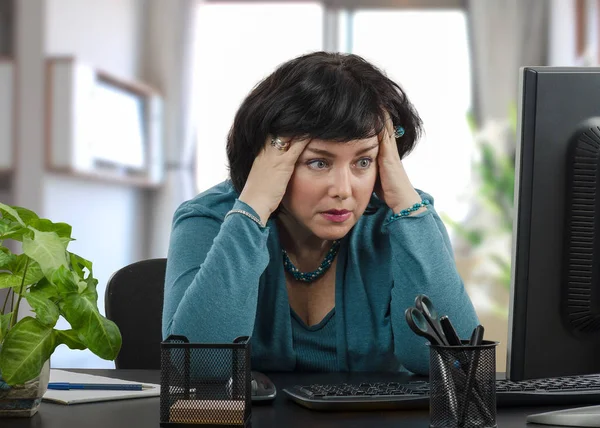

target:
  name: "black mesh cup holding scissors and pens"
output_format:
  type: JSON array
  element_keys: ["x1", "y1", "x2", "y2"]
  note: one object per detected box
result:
[{"x1": 429, "y1": 340, "x2": 498, "y2": 428}]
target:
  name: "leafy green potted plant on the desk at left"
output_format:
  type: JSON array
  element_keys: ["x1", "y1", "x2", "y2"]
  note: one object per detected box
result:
[{"x1": 0, "y1": 203, "x2": 121, "y2": 416}]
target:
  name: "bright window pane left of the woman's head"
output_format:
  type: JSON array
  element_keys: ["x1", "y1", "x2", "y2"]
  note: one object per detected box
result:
[{"x1": 196, "y1": 3, "x2": 323, "y2": 192}]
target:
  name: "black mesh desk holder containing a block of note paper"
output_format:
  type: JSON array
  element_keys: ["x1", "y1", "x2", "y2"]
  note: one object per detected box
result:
[{"x1": 160, "y1": 336, "x2": 252, "y2": 428}]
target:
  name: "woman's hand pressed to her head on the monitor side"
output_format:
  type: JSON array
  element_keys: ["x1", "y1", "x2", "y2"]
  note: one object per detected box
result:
[{"x1": 375, "y1": 111, "x2": 424, "y2": 214}]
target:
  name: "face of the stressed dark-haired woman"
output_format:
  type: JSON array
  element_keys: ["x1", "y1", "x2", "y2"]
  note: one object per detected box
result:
[{"x1": 282, "y1": 136, "x2": 379, "y2": 240}]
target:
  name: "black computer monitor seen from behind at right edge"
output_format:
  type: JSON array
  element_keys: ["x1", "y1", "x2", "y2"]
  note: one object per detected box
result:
[{"x1": 507, "y1": 67, "x2": 600, "y2": 380}]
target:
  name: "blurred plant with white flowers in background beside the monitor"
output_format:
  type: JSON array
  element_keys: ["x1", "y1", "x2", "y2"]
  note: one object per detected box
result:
[{"x1": 442, "y1": 106, "x2": 517, "y2": 320}]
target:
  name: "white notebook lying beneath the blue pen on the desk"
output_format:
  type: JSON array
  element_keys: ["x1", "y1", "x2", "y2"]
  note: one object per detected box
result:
[{"x1": 43, "y1": 369, "x2": 160, "y2": 404}]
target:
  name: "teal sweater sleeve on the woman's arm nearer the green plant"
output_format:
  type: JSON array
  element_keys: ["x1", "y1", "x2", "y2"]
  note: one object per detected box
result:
[{"x1": 162, "y1": 200, "x2": 269, "y2": 343}]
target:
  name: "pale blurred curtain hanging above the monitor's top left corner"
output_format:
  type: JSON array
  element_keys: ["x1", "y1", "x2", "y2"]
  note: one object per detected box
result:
[{"x1": 467, "y1": 0, "x2": 550, "y2": 127}]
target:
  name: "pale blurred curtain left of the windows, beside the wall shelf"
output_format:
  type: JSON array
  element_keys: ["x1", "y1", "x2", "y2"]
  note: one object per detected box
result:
[{"x1": 143, "y1": 0, "x2": 197, "y2": 258}]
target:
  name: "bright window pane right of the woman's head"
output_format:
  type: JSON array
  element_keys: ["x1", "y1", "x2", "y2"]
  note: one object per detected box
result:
[{"x1": 349, "y1": 10, "x2": 473, "y2": 220}]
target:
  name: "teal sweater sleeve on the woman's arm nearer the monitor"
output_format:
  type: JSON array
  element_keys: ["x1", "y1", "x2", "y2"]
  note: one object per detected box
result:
[{"x1": 384, "y1": 193, "x2": 478, "y2": 375}]
